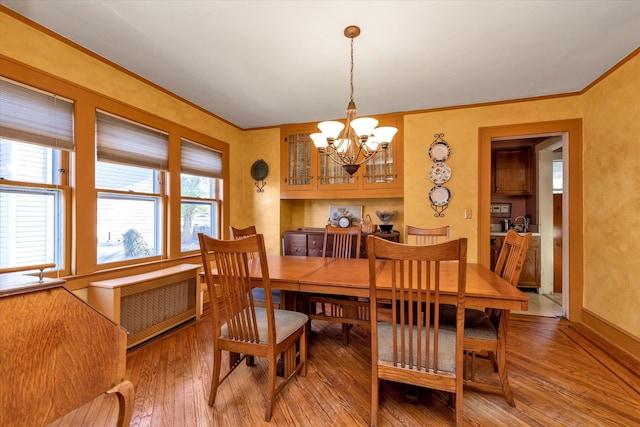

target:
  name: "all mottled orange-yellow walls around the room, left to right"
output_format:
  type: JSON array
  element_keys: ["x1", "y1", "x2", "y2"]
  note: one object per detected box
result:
[{"x1": 0, "y1": 8, "x2": 640, "y2": 354}]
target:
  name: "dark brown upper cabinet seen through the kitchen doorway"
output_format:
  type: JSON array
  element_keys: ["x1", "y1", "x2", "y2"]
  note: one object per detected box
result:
[{"x1": 492, "y1": 147, "x2": 532, "y2": 196}]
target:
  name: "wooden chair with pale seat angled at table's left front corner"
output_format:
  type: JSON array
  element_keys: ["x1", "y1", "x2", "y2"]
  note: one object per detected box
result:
[{"x1": 198, "y1": 233, "x2": 309, "y2": 421}]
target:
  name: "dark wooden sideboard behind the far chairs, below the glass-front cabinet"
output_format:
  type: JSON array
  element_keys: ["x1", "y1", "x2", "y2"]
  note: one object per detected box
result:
[{"x1": 282, "y1": 227, "x2": 400, "y2": 258}]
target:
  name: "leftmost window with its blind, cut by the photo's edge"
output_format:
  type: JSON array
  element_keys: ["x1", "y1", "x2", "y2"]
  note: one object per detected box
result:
[{"x1": 0, "y1": 78, "x2": 74, "y2": 270}]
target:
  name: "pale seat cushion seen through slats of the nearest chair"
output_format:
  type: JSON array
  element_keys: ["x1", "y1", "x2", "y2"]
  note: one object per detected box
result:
[{"x1": 378, "y1": 322, "x2": 456, "y2": 373}]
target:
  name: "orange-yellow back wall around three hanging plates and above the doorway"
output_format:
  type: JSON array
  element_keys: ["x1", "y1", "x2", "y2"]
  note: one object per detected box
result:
[{"x1": 404, "y1": 97, "x2": 582, "y2": 262}]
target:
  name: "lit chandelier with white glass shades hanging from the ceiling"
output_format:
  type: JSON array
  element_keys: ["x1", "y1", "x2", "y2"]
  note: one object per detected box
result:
[{"x1": 310, "y1": 25, "x2": 398, "y2": 175}]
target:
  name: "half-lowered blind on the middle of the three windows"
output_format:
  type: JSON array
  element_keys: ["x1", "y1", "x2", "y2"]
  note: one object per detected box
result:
[{"x1": 96, "y1": 111, "x2": 169, "y2": 170}]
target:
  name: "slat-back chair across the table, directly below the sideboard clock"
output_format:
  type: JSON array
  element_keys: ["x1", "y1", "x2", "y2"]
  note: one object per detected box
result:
[{"x1": 307, "y1": 225, "x2": 369, "y2": 345}]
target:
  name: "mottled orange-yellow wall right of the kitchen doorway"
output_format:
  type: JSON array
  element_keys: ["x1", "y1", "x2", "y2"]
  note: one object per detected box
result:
[{"x1": 583, "y1": 51, "x2": 640, "y2": 337}]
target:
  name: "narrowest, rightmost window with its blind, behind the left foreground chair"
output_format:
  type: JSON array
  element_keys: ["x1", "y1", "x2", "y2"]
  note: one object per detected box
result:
[{"x1": 180, "y1": 139, "x2": 222, "y2": 252}]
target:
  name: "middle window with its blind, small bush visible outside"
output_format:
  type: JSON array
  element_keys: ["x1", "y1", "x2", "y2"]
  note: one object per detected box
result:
[{"x1": 96, "y1": 112, "x2": 169, "y2": 264}]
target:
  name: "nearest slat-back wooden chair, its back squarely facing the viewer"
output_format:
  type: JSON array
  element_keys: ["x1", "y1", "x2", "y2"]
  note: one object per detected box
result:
[{"x1": 367, "y1": 237, "x2": 467, "y2": 426}]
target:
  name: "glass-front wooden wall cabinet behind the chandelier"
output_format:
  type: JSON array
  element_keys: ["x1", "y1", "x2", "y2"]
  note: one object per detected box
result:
[{"x1": 280, "y1": 115, "x2": 404, "y2": 199}]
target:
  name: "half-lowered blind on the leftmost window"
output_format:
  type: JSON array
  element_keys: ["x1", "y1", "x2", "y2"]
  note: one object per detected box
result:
[{"x1": 0, "y1": 78, "x2": 74, "y2": 151}]
